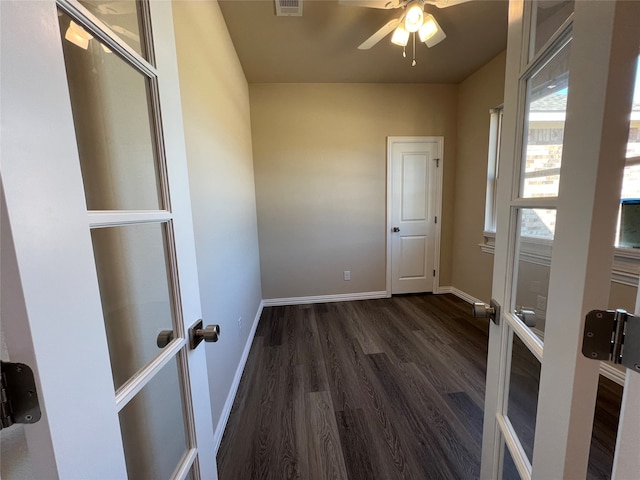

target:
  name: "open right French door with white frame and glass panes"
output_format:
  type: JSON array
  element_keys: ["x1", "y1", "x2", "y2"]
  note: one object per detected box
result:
[{"x1": 481, "y1": 0, "x2": 640, "y2": 479}]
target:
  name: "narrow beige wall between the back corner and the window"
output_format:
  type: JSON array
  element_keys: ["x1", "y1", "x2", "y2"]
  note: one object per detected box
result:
[{"x1": 451, "y1": 52, "x2": 505, "y2": 301}]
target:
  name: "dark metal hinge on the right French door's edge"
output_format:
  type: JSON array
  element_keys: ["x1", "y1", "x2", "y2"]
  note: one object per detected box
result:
[{"x1": 582, "y1": 309, "x2": 640, "y2": 372}]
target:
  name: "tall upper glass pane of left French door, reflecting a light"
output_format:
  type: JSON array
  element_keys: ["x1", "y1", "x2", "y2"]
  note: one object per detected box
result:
[{"x1": 59, "y1": 12, "x2": 162, "y2": 210}]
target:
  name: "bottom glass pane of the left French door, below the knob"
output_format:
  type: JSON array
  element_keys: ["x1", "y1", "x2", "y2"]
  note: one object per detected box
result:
[{"x1": 120, "y1": 357, "x2": 188, "y2": 480}]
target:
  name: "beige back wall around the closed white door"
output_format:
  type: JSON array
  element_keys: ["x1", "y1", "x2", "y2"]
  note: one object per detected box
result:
[{"x1": 249, "y1": 84, "x2": 457, "y2": 299}]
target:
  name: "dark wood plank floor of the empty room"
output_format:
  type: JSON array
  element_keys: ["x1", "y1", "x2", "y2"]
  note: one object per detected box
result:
[{"x1": 218, "y1": 295, "x2": 621, "y2": 480}]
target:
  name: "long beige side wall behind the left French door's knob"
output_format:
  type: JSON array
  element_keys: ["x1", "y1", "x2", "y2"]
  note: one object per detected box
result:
[{"x1": 173, "y1": 1, "x2": 262, "y2": 442}]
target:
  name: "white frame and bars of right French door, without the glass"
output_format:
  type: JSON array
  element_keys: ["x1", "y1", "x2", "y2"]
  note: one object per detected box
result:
[{"x1": 481, "y1": 0, "x2": 640, "y2": 479}]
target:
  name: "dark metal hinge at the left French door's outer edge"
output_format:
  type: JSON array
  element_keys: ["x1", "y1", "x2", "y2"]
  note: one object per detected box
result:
[{"x1": 0, "y1": 362, "x2": 41, "y2": 429}]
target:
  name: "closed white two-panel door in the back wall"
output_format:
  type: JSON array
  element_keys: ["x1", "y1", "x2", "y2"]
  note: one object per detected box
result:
[{"x1": 387, "y1": 137, "x2": 443, "y2": 294}]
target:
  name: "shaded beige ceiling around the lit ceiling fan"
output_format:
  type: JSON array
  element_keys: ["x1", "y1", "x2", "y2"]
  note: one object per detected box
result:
[{"x1": 219, "y1": 0, "x2": 508, "y2": 83}]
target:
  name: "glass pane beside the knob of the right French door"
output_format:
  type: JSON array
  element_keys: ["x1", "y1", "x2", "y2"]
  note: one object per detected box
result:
[{"x1": 511, "y1": 208, "x2": 556, "y2": 339}]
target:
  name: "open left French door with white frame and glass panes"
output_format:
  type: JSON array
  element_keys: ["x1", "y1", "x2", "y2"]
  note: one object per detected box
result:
[{"x1": 0, "y1": 0, "x2": 216, "y2": 479}]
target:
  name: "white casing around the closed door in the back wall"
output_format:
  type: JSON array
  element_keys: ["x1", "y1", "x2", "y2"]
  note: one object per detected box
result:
[{"x1": 385, "y1": 136, "x2": 444, "y2": 297}]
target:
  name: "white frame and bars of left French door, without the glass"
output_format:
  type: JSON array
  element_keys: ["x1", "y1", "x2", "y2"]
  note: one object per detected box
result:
[{"x1": 0, "y1": 1, "x2": 216, "y2": 478}]
